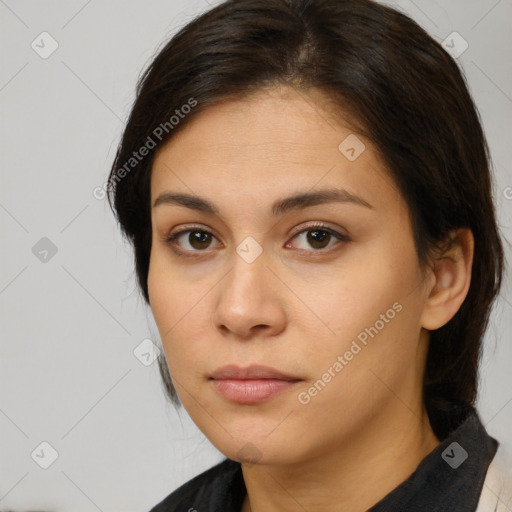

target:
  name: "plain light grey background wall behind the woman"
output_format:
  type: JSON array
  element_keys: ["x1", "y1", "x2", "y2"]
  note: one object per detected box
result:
[{"x1": 0, "y1": 0, "x2": 512, "y2": 512}]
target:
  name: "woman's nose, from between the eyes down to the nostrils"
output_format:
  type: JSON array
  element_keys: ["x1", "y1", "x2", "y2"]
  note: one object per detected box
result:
[{"x1": 212, "y1": 247, "x2": 290, "y2": 340}]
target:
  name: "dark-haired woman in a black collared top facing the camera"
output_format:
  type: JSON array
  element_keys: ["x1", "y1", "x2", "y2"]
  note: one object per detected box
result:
[{"x1": 109, "y1": 0, "x2": 510, "y2": 512}]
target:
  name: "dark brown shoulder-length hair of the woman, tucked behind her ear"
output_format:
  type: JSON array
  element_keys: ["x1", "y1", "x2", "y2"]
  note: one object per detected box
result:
[{"x1": 108, "y1": 0, "x2": 504, "y2": 439}]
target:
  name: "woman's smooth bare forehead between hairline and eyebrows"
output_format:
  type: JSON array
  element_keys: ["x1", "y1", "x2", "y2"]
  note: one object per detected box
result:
[{"x1": 151, "y1": 88, "x2": 401, "y2": 216}]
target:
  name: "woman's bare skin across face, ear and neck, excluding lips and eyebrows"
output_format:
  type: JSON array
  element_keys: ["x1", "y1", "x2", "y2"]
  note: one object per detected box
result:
[{"x1": 148, "y1": 87, "x2": 473, "y2": 512}]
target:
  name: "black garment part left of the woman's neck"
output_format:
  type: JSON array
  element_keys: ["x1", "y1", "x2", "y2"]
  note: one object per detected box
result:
[{"x1": 150, "y1": 459, "x2": 245, "y2": 512}]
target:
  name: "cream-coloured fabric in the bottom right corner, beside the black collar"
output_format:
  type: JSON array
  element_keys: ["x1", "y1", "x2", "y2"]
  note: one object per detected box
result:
[{"x1": 476, "y1": 444, "x2": 512, "y2": 512}]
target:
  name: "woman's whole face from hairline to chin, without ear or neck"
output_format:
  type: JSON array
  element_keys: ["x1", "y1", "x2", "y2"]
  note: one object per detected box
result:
[{"x1": 148, "y1": 89, "x2": 434, "y2": 464}]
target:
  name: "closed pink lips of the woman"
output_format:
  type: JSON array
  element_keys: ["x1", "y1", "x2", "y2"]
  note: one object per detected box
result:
[{"x1": 209, "y1": 365, "x2": 302, "y2": 405}]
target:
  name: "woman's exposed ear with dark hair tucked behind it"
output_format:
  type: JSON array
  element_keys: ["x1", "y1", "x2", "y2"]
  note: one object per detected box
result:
[{"x1": 421, "y1": 228, "x2": 475, "y2": 330}]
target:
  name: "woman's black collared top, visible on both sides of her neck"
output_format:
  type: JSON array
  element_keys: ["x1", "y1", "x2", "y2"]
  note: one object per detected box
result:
[{"x1": 150, "y1": 406, "x2": 499, "y2": 512}]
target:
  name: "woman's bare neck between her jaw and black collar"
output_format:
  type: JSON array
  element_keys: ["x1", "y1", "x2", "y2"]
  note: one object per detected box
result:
[{"x1": 242, "y1": 399, "x2": 440, "y2": 512}]
